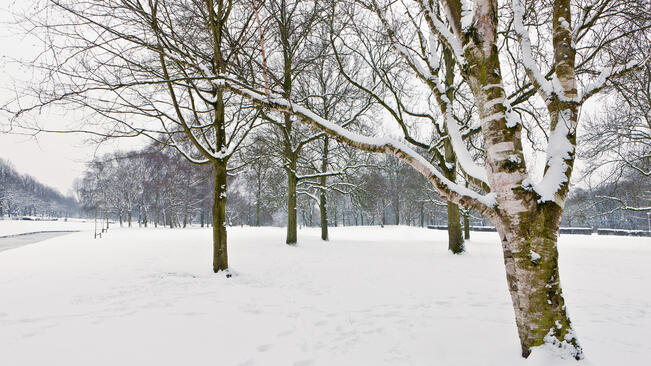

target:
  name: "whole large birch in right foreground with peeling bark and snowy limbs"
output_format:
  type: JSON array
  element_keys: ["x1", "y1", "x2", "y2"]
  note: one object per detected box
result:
[{"x1": 215, "y1": 0, "x2": 649, "y2": 359}]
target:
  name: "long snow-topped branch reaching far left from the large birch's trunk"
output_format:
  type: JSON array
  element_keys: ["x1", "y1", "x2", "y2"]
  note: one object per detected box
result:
[{"x1": 215, "y1": 76, "x2": 497, "y2": 216}]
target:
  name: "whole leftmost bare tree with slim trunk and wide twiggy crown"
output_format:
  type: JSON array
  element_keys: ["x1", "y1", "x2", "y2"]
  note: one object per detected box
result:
[{"x1": 8, "y1": 0, "x2": 257, "y2": 272}]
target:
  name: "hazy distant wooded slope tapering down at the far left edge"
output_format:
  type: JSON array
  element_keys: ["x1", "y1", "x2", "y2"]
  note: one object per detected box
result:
[{"x1": 0, "y1": 159, "x2": 79, "y2": 218}]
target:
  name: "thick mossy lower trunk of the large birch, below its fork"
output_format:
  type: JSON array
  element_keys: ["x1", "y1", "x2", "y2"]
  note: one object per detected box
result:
[{"x1": 496, "y1": 203, "x2": 582, "y2": 359}]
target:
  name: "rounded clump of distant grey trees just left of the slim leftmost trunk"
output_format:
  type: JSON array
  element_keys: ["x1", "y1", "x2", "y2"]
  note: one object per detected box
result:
[{"x1": 75, "y1": 148, "x2": 212, "y2": 228}]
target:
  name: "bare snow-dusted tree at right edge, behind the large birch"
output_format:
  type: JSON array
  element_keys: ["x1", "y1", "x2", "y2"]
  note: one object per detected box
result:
[{"x1": 579, "y1": 65, "x2": 651, "y2": 212}]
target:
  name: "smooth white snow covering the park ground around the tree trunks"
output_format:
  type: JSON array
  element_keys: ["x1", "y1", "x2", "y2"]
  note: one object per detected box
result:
[{"x1": 0, "y1": 227, "x2": 651, "y2": 366}]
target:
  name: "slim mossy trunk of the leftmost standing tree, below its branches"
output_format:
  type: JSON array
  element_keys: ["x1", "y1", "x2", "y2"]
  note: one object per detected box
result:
[{"x1": 212, "y1": 160, "x2": 228, "y2": 273}]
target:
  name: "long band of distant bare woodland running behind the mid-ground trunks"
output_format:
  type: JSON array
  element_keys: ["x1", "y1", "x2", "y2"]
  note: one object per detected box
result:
[{"x1": 75, "y1": 137, "x2": 494, "y2": 232}]
